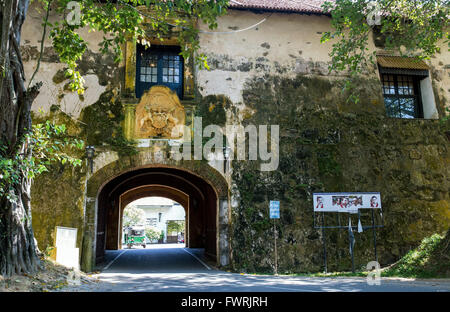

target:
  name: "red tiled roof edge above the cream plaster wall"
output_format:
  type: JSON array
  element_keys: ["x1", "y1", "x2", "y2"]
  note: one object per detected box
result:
[{"x1": 229, "y1": 0, "x2": 334, "y2": 13}]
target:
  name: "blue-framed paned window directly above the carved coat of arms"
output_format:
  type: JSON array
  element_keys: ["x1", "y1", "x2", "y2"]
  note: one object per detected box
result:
[{"x1": 136, "y1": 44, "x2": 183, "y2": 99}]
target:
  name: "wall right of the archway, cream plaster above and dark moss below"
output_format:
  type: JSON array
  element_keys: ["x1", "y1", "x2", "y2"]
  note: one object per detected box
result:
[{"x1": 192, "y1": 11, "x2": 450, "y2": 272}]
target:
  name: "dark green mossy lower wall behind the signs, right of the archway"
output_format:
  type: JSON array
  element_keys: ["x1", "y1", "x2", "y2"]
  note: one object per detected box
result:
[{"x1": 232, "y1": 76, "x2": 450, "y2": 272}]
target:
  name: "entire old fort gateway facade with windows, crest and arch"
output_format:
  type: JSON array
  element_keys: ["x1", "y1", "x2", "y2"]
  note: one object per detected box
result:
[{"x1": 21, "y1": 0, "x2": 450, "y2": 273}]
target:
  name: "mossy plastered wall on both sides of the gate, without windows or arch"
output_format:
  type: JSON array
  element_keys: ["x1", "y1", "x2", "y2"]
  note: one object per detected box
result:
[{"x1": 22, "y1": 4, "x2": 450, "y2": 272}]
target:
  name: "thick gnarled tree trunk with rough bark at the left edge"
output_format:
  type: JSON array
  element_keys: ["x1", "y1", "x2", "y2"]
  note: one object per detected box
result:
[{"x1": 0, "y1": 0, "x2": 41, "y2": 276}]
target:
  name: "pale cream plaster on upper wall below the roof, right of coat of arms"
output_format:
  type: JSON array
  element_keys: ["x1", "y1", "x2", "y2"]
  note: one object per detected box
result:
[{"x1": 196, "y1": 10, "x2": 450, "y2": 114}]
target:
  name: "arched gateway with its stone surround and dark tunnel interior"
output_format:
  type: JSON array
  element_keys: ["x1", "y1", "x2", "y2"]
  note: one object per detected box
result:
[{"x1": 81, "y1": 154, "x2": 231, "y2": 272}]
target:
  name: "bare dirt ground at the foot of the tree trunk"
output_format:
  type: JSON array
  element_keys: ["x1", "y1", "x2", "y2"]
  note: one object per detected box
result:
[{"x1": 0, "y1": 260, "x2": 99, "y2": 292}]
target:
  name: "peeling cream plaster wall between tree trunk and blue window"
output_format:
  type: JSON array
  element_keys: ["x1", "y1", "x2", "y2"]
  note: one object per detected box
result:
[{"x1": 21, "y1": 2, "x2": 119, "y2": 118}]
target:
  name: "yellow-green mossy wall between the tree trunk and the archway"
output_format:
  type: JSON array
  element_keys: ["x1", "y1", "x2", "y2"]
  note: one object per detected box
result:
[{"x1": 31, "y1": 108, "x2": 85, "y2": 252}]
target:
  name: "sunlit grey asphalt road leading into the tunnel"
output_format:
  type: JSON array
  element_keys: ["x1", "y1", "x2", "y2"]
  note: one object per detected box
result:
[{"x1": 59, "y1": 244, "x2": 450, "y2": 292}]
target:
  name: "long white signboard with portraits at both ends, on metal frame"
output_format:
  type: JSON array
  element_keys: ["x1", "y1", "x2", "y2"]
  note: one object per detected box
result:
[{"x1": 313, "y1": 192, "x2": 381, "y2": 213}]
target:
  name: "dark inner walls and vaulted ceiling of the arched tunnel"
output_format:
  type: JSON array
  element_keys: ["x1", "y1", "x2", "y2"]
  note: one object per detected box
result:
[{"x1": 95, "y1": 167, "x2": 221, "y2": 263}]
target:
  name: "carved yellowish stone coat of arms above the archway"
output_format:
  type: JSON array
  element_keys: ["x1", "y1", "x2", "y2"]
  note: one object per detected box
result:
[{"x1": 135, "y1": 86, "x2": 185, "y2": 139}]
